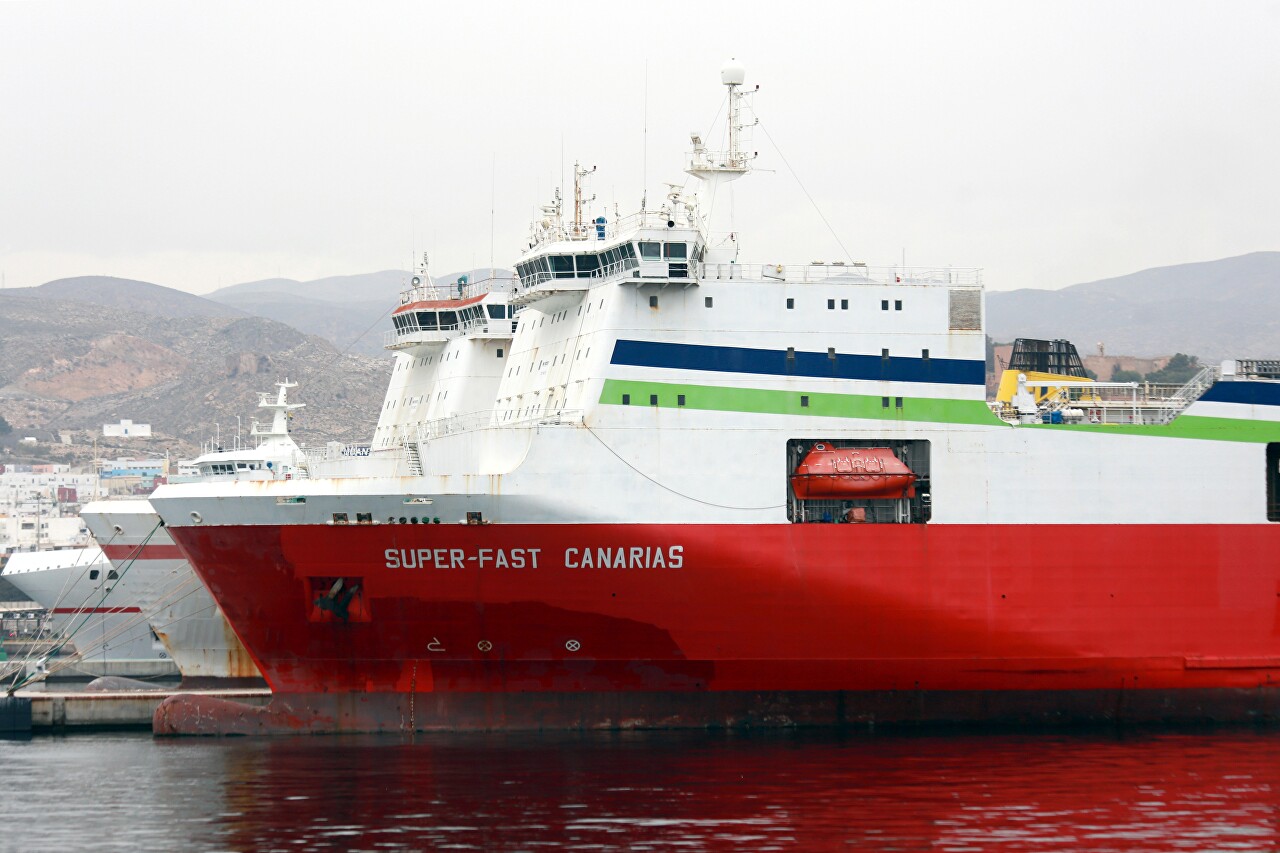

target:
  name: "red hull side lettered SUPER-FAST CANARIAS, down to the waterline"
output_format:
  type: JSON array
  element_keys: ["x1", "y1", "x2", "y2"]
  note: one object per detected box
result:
[{"x1": 157, "y1": 524, "x2": 1280, "y2": 730}]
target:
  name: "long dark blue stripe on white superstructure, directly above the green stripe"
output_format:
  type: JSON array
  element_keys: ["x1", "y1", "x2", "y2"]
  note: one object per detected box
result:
[{"x1": 612, "y1": 339, "x2": 987, "y2": 386}]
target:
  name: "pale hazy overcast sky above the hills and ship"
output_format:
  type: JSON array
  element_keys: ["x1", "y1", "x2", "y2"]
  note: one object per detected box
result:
[{"x1": 0, "y1": 0, "x2": 1280, "y2": 292}]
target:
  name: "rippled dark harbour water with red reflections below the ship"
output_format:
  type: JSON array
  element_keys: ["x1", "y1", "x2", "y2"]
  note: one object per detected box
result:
[{"x1": 0, "y1": 731, "x2": 1280, "y2": 850}]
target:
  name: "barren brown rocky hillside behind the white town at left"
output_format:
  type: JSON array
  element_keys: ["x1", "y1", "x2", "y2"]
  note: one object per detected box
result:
[{"x1": 0, "y1": 279, "x2": 388, "y2": 456}]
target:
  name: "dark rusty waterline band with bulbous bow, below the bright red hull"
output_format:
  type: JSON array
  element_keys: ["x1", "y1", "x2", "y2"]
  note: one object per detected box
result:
[{"x1": 152, "y1": 688, "x2": 1280, "y2": 736}]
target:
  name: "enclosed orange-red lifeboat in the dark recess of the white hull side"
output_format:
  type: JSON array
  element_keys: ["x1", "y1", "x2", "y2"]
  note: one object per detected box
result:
[{"x1": 791, "y1": 442, "x2": 915, "y2": 501}]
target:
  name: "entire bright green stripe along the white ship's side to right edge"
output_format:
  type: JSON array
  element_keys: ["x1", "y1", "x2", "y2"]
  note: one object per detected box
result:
[{"x1": 600, "y1": 379, "x2": 1280, "y2": 443}]
